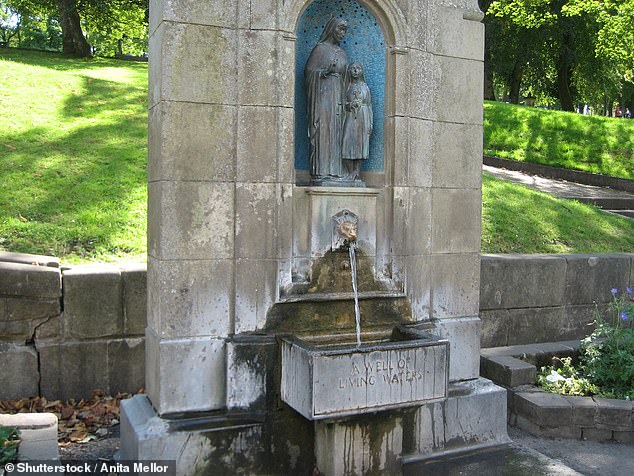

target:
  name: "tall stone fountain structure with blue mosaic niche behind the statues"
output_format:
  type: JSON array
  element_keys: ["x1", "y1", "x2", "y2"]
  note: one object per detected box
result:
[{"x1": 121, "y1": 0, "x2": 507, "y2": 475}]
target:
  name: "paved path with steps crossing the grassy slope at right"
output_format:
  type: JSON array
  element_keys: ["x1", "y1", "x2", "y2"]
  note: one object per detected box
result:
[{"x1": 482, "y1": 165, "x2": 634, "y2": 218}]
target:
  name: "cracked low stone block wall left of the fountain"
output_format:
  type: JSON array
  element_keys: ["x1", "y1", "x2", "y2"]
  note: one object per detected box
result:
[{"x1": 0, "y1": 253, "x2": 146, "y2": 399}]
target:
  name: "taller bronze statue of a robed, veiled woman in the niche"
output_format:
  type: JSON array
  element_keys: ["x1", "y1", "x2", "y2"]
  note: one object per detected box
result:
[{"x1": 304, "y1": 17, "x2": 348, "y2": 182}]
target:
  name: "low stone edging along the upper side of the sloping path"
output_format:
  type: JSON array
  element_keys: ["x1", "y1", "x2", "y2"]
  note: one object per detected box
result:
[{"x1": 483, "y1": 155, "x2": 634, "y2": 193}]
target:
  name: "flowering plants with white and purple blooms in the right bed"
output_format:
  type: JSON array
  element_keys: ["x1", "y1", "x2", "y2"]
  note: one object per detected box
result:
[{"x1": 537, "y1": 288, "x2": 634, "y2": 400}]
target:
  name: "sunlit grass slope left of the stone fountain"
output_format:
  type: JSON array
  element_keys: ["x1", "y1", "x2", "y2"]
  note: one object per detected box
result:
[{"x1": 0, "y1": 49, "x2": 147, "y2": 262}]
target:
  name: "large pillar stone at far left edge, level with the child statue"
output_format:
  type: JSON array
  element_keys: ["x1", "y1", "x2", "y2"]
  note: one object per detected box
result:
[{"x1": 148, "y1": 101, "x2": 238, "y2": 182}]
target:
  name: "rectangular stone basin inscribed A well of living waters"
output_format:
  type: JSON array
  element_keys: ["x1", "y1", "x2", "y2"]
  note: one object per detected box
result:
[{"x1": 281, "y1": 326, "x2": 449, "y2": 420}]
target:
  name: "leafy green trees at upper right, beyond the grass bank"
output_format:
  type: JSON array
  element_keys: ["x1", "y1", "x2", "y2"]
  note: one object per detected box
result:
[{"x1": 480, "y1": 0, "x2": 634, "y2": 112}]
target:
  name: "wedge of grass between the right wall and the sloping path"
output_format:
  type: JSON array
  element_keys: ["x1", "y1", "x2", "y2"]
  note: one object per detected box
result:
[{"x1": 482, "y1": 174, "x2": 634, "y2": 253}]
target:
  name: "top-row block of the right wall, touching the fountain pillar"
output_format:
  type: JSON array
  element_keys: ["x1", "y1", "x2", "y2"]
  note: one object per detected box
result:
[{"x1": 480, "y1": 255, "x2": 566, "y2": 310}]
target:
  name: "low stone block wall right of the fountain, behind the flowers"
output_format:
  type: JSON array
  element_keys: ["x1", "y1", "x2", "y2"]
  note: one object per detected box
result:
[{"x1": 480, "y1": 253, "x2": 634, "y2": 347}]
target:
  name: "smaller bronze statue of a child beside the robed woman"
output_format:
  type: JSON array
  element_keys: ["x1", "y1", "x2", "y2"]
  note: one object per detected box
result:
[{"x1": 341, "y1": 63, "x2": 373, "y2": 180}]
